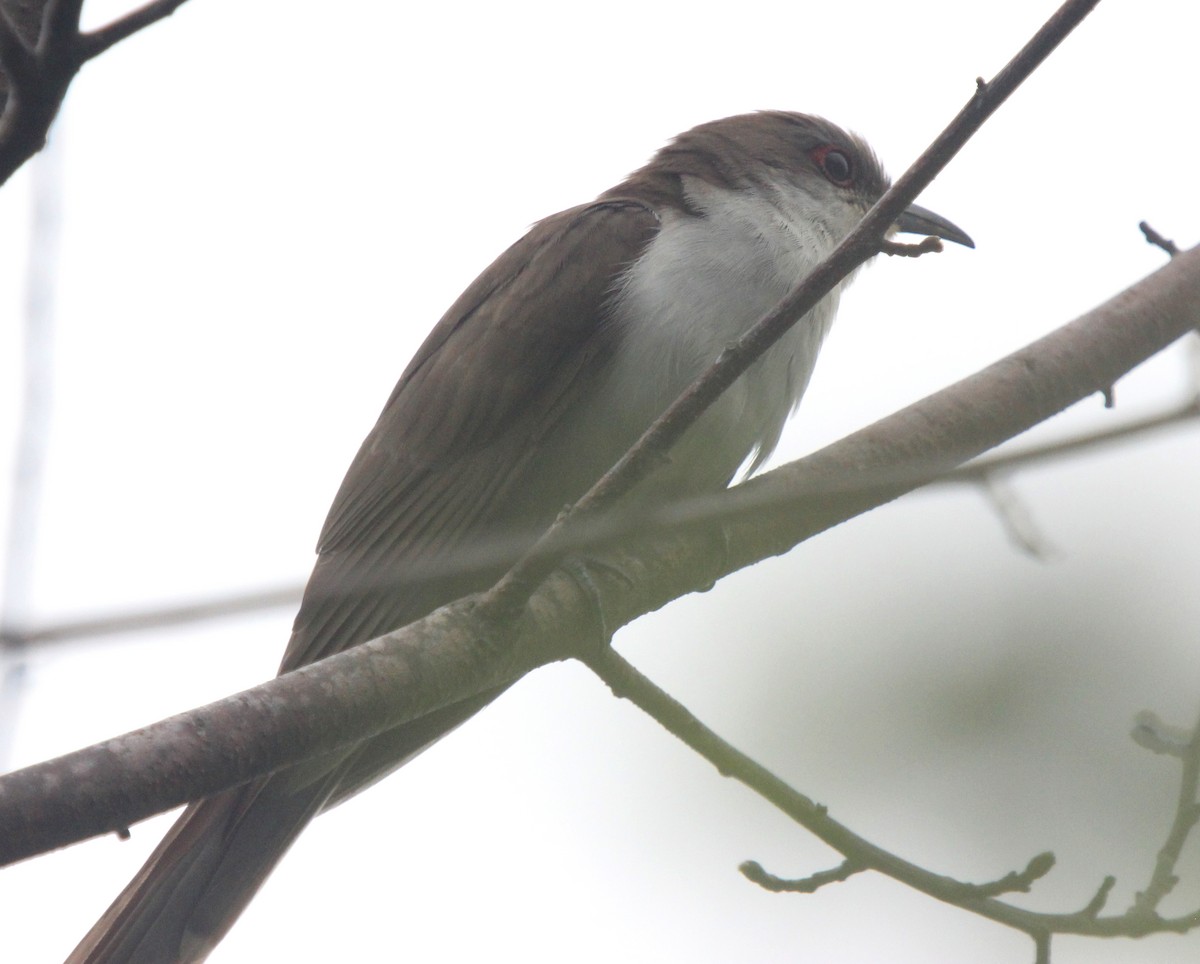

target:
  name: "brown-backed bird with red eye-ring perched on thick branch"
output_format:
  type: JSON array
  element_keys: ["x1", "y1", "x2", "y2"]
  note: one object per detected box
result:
[{"x1": 68, "y1": 110, "x2": 974, "y2": 964}]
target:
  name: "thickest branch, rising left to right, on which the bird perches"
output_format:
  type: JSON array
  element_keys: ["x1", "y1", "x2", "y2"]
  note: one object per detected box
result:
[{"x1": 0, "y1": 249, "x2": 1200, "y2": 862}]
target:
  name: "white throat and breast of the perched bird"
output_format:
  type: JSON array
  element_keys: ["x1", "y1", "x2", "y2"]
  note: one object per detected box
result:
[{"x1": 610, "y1": 174, "x2": 848, "y2": 484}]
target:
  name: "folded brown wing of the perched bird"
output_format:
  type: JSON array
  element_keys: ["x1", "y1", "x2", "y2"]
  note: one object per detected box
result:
[{"x1": 281, "y1": 199, "x2": 659, "y2": 671}]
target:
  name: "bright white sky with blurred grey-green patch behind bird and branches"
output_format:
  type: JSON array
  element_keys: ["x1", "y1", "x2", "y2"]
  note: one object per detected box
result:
[{"x1": 0, "y1": 0, "x2": 1200, "y2": 964}]
